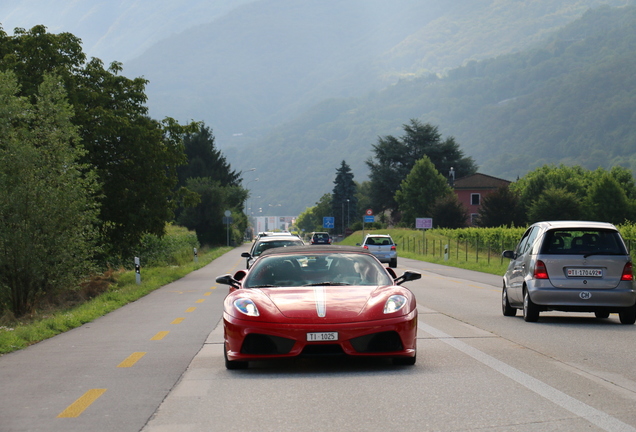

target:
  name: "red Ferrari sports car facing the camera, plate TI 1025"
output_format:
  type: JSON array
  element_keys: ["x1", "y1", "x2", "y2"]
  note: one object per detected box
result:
[{"x1": 216, "y1": 245, "x2": 421, "y2": 369}]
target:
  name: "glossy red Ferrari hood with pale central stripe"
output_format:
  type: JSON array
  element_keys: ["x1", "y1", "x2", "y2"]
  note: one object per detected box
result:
[{"x1": 262, "y1": 286, "x2": 377, "y2": 320}]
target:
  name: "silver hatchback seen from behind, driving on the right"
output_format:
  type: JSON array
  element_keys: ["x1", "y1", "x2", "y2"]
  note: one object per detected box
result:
[{"x1": 501, "y1": 221, "x2": 636, "y2": 324}]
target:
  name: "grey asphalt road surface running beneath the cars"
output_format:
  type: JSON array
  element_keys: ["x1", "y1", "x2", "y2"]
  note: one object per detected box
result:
[{"x1": 0, "y1": 246, "x2": 636, "y2": 432}]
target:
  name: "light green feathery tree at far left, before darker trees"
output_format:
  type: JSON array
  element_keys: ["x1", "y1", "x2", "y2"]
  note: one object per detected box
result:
[{"x1": 0, "y1": 72, "x2": 98, "y2": 316}]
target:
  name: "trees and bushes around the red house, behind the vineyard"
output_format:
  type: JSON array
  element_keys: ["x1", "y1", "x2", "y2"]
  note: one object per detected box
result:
[{"x1": 297, "y1": 119, "x2": 636, "y2": 234}]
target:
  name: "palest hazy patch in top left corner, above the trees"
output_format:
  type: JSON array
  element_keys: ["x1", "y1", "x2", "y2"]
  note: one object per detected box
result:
[{"x1": 0, "y1": 0, "x2": 253, "y2": 64}]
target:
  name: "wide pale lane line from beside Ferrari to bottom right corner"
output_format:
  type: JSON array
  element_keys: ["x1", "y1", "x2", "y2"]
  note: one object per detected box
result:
[{"x1": 417, "y1": 319, "x2": 636, "y2": 432}]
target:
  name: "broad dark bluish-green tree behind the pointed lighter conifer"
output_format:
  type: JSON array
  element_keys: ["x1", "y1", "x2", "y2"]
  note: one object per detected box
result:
[{"x1": 366, "y1": 119, "x2": 477, "y2": 218}]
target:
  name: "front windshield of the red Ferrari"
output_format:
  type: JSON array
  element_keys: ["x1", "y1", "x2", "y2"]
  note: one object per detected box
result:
[{"x1": 243, "y1": 253, "x2": 393, "y2": 288}]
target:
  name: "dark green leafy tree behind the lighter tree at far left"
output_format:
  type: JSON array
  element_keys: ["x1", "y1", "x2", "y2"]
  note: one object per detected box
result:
[{"x1": 0, "y1": 26, "x2": 195, "y2": 259}]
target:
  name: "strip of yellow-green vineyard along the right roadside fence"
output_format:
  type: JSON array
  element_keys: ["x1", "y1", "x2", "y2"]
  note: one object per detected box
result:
[{"x1": 338, "y1": 228, "x2": 509, "y2": 275}]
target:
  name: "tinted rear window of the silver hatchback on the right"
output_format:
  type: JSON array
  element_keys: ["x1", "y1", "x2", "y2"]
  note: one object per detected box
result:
[{"x1": 541, "y1": 228, "x2": 627, "y2": 255}]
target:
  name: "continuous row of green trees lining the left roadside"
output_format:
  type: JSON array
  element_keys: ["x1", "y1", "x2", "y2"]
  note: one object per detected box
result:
[{"x1": 0, "y1": 26, "x2": 247, "y2": 316}]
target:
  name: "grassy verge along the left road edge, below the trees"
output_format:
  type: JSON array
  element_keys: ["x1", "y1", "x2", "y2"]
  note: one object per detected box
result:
[{"x1": 0, "y1": 247, "x2": 231, "y2": 354}]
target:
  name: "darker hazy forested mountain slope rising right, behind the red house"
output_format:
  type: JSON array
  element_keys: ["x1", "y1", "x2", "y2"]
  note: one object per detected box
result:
[{"x1": 240, "y1": 1, "x2": 636, "y2": 214}]
